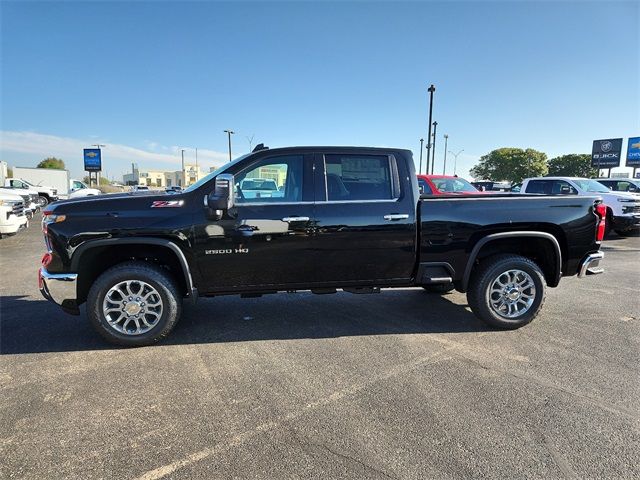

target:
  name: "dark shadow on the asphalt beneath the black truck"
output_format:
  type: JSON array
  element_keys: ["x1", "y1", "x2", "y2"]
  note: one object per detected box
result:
[{"x1": 0, "y1": 289, "x2": 492, "y2": 355}]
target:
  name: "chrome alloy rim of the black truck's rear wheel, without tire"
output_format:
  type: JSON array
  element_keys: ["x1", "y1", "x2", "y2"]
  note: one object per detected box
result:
[{"x1": 487, "y1": 270, "x2": 536, "y2": 318}]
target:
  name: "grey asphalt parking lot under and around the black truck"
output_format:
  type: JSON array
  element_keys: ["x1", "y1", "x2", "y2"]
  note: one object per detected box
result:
[{"x1": 0, "y1": 218, "x2": 640, "y2": 479}]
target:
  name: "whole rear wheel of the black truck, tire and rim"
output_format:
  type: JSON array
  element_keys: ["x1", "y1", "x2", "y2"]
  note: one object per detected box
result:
[{"x1": 467, "y1": 255, "x2": 547, "y2": 329}]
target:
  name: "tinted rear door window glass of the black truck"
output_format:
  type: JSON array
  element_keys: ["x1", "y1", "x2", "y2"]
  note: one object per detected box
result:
[{"x1": 325, "y1": 154, "x2": 393, "y2": 201}]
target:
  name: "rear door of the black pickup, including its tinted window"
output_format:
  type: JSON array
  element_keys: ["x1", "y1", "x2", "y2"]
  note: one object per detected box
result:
[{"x1": 313, "y1": 150, "x2": 416, "y2": 285}]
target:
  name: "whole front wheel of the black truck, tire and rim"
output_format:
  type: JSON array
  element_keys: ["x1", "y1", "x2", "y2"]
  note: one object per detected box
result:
[{"x1": 87, "y1": 261, "x2": 182, "y2": 347}]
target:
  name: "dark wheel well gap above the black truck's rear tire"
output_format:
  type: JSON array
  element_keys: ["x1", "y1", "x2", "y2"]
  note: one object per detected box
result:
[{"x1": 467, "y1": 236, "x2": 560, "y2": 287}]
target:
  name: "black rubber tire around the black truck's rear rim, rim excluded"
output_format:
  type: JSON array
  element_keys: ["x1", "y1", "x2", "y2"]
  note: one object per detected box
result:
[{"x1": 467, "y1": 254, "x2": 547, "y2": 330}]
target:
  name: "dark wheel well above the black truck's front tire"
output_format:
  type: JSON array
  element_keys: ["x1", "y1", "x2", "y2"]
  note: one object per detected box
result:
[{"x1": 77, "y1": 244, "x2": 189, "y2": 305}]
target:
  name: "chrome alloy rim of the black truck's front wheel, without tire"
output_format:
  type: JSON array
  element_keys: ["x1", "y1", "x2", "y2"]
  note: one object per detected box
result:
[{"x1": 102, "y1": 280, "x2": 163, "y2": 335}]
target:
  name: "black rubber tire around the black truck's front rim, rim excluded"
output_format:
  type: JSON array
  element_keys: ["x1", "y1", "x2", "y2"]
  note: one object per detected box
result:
[{"x1": 87, "y1": 261, "x2": 182, "y2": 347}]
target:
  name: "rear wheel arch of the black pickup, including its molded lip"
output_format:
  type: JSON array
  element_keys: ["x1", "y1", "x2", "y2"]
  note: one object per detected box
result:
[{"x1": 462, "y1": 231, "x2": 562, "y2": 291}]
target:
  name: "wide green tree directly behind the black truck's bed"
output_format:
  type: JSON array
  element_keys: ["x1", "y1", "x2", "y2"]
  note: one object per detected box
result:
[{"x1": 470, "y1": 148, "x2": 548, "y2": 183}]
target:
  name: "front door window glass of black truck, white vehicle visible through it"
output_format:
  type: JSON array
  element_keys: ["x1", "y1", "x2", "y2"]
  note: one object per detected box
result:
[{"x1": 235, "y1": 155, "x2": 303, "y2": 203}]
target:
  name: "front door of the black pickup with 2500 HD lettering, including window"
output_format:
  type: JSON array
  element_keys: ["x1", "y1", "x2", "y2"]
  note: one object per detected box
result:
[{"x1": 195, "y1": 154, "x2": 314, "y2": 293}]
